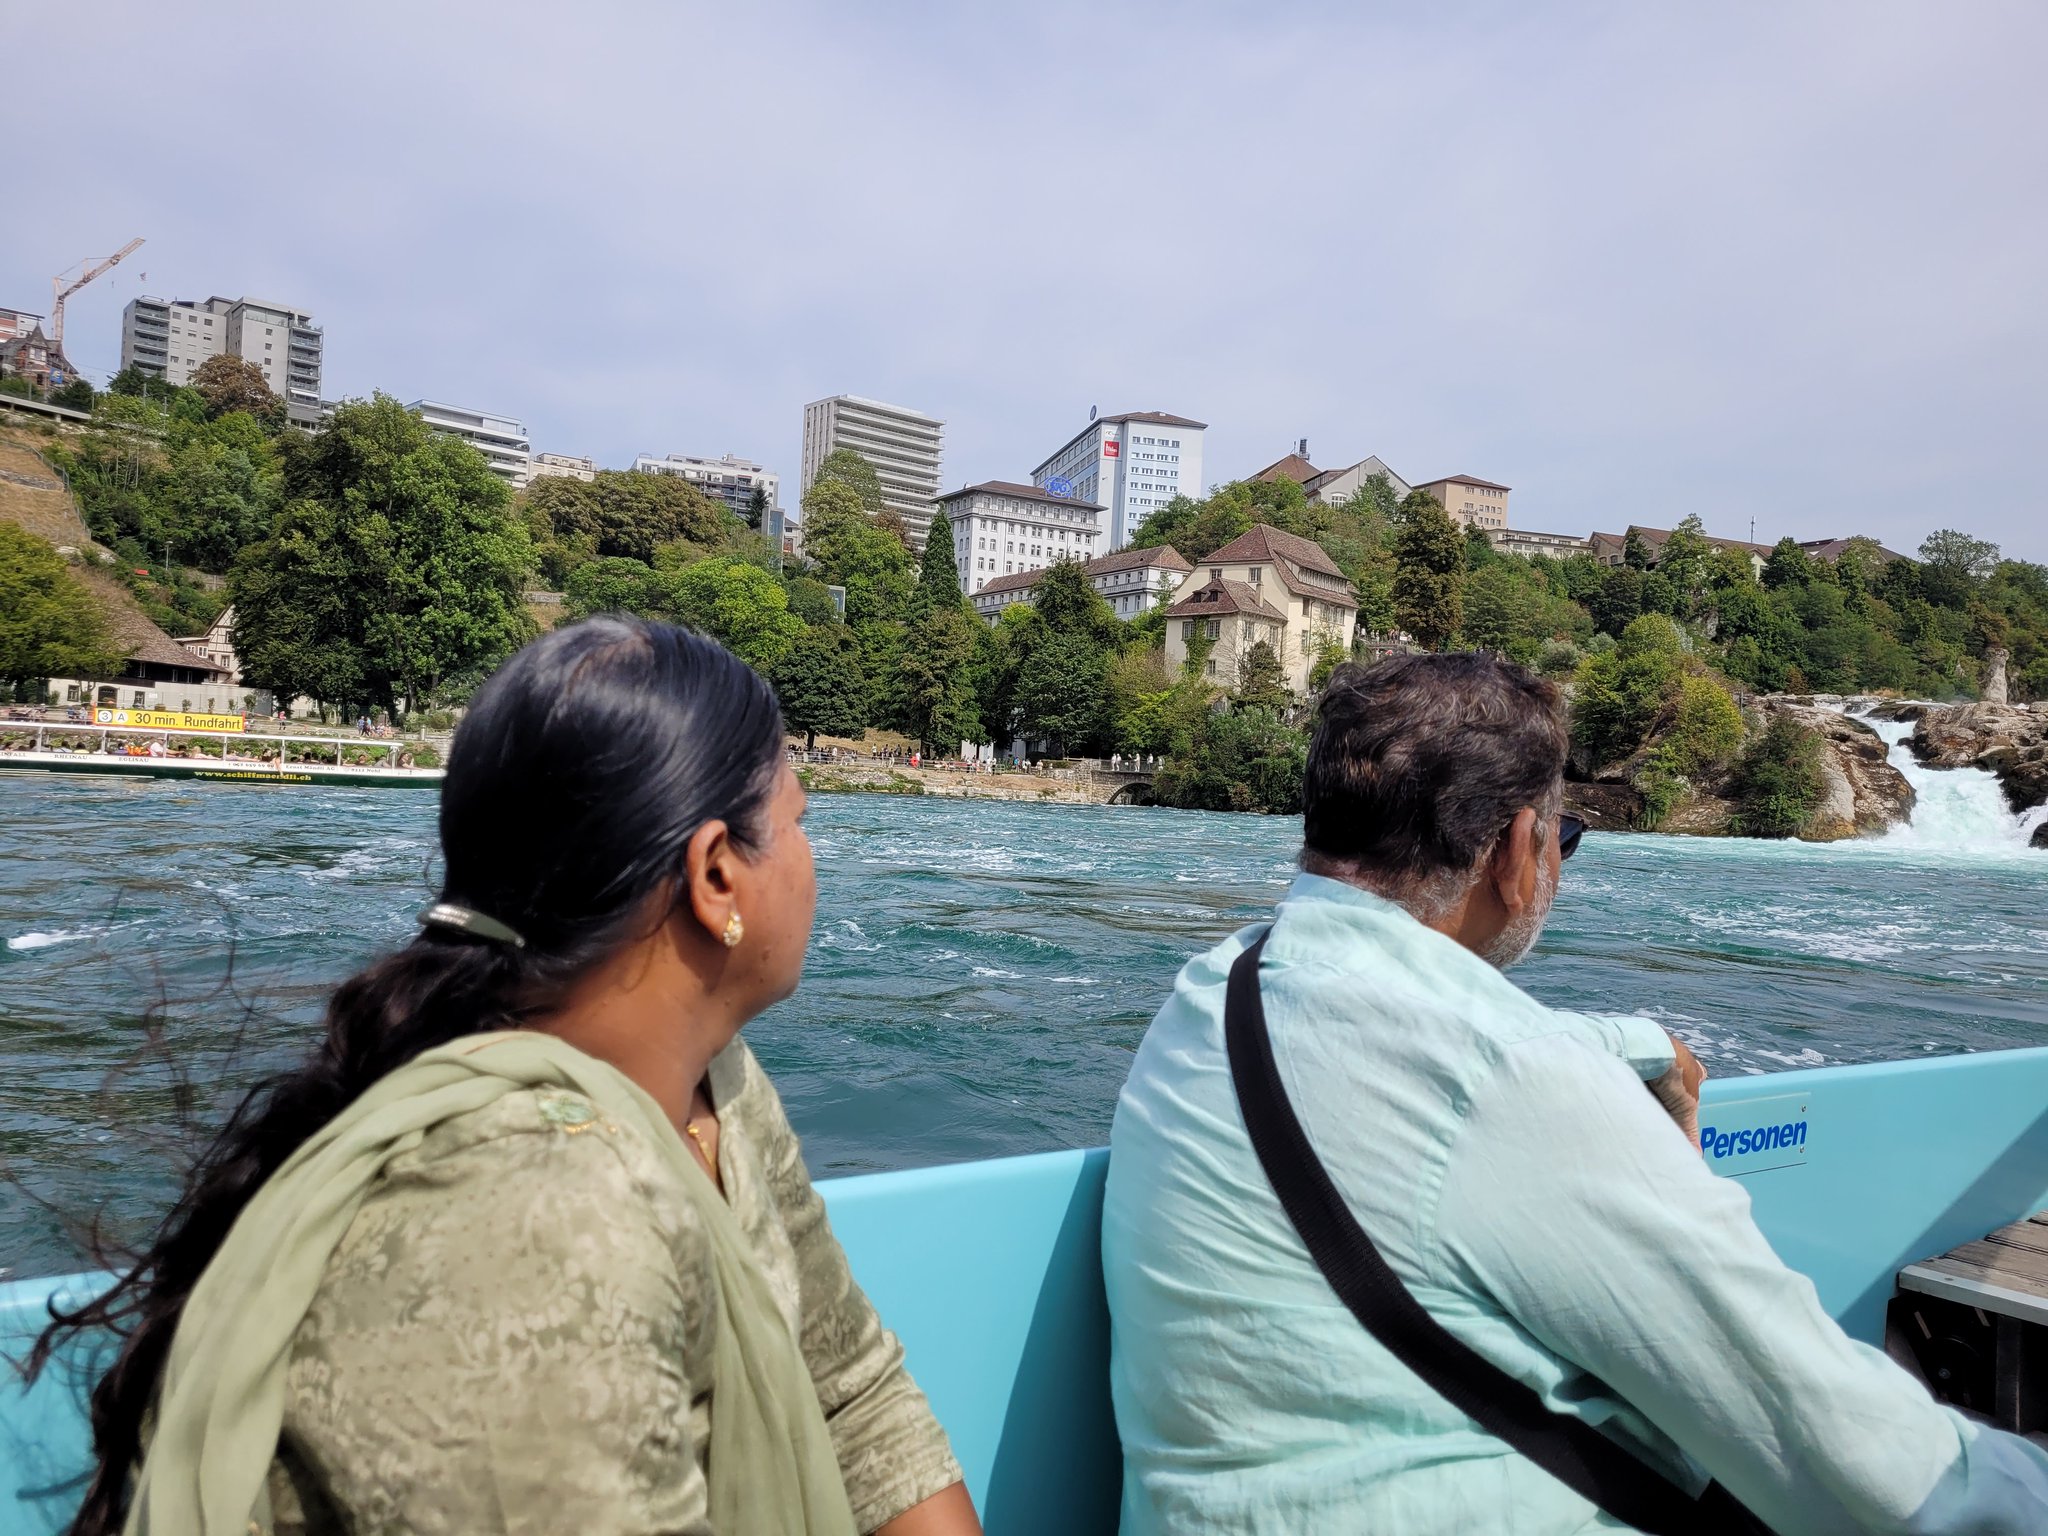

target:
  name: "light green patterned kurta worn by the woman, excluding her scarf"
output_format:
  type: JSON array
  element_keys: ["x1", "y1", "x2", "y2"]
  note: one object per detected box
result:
[{"x1": 270, "y1": 1042, "x2": 961, "y2": 1536}]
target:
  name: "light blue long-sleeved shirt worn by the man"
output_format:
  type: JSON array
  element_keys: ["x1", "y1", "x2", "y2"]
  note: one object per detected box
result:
[{"x1": 1102, "y1": 874, "x2": 2048, "y2": 1536}]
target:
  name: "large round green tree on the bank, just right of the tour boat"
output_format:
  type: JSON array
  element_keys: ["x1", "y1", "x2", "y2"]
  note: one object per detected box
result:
[{"x1": 227, "y1": 395, "x2": 532, "y2": 715}]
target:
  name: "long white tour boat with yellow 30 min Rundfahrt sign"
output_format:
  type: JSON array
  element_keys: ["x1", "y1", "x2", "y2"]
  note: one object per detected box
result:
[{"x1": 0, "y1": 711, "x2": 446, "y2": 788}]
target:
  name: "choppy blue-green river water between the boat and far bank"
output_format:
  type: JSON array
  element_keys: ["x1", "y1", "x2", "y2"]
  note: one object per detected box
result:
[{"x1": 0, "y1": 749, "x2": 2048, "y2": 1278}]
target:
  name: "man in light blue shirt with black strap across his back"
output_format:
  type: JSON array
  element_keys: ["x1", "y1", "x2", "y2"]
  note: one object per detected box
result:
[{"x1": 1102, "y1": 655, "x2": 2048, "y2": 1536}]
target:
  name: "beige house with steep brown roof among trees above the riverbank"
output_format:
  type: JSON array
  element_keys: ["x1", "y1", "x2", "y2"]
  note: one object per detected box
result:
[{"x1": 1165, "y1": 522, "x2": 1358, "y2": 694}]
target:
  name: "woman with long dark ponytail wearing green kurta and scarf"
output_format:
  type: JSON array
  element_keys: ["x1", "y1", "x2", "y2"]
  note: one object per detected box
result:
[{"x1": 39, "y1": 618, "x2": 979, "y2": 1536}]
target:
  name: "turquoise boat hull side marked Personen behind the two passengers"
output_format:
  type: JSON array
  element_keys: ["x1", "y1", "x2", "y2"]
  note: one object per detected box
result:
[{"x1": 0, "y1": 1049, "x2": 2048, "y2": 1536}]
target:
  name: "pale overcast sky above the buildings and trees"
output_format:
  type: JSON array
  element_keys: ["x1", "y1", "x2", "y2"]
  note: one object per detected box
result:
[{"x1": 16, "y1": 0, "x2": 2048, "y2": 559}]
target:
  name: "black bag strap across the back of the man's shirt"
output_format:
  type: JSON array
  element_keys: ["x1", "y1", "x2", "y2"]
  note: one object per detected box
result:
[{"x1": 1223, "y1": 934, "x2": 1763, "y2": 1536}]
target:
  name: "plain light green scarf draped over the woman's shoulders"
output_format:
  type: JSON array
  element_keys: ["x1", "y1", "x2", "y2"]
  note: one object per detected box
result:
[{"x1": 125, "y1": 1032, "x2": 854, "y2": 1536}]
